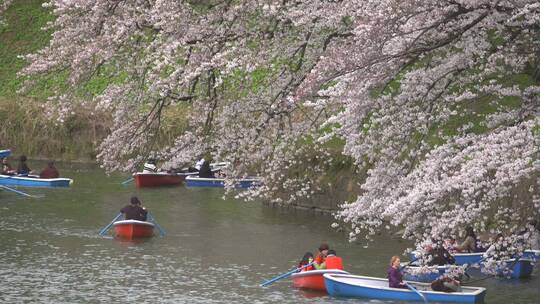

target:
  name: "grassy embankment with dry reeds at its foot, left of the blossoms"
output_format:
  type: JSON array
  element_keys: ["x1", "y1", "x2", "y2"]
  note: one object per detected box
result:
[{"x1": 0, "y1": 0, "x2": 107, "y2": 160}]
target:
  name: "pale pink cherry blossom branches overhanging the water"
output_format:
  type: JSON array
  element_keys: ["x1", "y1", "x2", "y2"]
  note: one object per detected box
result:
[{"x1": 21, "y1": 0, "x2": 540, "y2": 258}]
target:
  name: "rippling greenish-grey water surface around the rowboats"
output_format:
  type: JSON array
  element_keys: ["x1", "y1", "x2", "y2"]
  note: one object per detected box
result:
[{"x1": 0, "y1": 163, "x2": 540, "y2": 303}]
